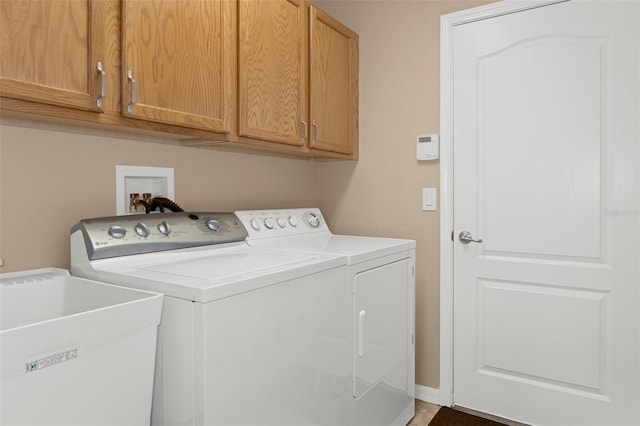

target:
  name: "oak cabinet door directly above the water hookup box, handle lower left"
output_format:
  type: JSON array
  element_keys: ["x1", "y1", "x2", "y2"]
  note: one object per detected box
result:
[{"x1": 122, "y1": 0, "x2": 236, "y2": 133}]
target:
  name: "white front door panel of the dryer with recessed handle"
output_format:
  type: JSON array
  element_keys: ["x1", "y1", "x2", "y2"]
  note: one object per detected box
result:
[{"x1": 353, "y1": 259, "x2": 411, "y2": 398}]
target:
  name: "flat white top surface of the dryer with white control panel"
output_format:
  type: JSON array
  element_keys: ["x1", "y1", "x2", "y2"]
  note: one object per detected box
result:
[{"x1": 247, "y1": 234, "x2": 416, "y2": 265}]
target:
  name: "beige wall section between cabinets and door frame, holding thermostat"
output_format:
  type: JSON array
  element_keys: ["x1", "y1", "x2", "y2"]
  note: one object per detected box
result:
[{"x1": 314, "y1": 0, "x2": 490, "y2": 388}]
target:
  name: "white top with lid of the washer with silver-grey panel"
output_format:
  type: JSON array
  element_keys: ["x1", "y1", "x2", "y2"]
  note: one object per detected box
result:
[{"x1": 91, "y1": 244, "x2": 346, "y2": 303}]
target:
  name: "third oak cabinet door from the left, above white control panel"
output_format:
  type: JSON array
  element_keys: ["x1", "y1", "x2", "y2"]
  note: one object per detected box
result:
[{"x1": 238, "y1": 0, "x2": 308, "y2": 145}]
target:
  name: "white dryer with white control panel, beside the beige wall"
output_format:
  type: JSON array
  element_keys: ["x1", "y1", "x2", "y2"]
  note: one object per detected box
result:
[{"x1": 236, "y1": 208, "x2": 415, "y2": 426}]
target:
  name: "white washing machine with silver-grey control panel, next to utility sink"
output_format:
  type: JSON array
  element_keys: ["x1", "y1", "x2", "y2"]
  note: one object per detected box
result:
[{"x1": 71, "y1": 213, "x2": 352, "y2": 426}]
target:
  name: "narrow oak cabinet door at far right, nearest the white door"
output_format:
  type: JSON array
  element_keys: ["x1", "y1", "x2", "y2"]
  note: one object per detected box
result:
[{"x1": 309, "y1": 7, "x2": 358, "y2": 156}]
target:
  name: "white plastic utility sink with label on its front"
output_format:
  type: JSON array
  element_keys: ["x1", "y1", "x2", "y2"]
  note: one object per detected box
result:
[{"x1": 0, "y1": 268, "x2": 163, "y2": 425}]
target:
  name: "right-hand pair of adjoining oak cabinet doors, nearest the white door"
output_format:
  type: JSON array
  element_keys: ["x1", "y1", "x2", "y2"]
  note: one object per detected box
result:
[{"x1": 238, "y1": 0, "x2": 358, "y2": 158}]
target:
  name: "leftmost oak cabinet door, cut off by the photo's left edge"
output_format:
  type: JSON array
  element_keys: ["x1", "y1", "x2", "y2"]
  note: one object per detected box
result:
[{"x1": 0, "y1": 0, "x2": 100, "y2": 110}]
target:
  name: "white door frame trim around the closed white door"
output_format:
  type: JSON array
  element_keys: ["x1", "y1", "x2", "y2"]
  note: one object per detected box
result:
[{"x1": 439, "y1": 0, "x2": 569, "y2": 407}]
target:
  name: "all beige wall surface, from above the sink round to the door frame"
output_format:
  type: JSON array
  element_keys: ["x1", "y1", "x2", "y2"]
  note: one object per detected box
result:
[{"x1": 0, "y1": 0, "x2": 500, "y2": 414}]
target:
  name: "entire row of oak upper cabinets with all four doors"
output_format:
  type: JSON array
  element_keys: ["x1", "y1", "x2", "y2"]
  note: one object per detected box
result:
[{"x1": 0, "y1": 0, "x2": 358, "y2": 159}]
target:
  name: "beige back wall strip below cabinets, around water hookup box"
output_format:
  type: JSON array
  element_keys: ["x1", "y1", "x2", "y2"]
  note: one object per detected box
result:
[{"x1": 0, "y1": 119, "x2": 317, "y2": 273}]
